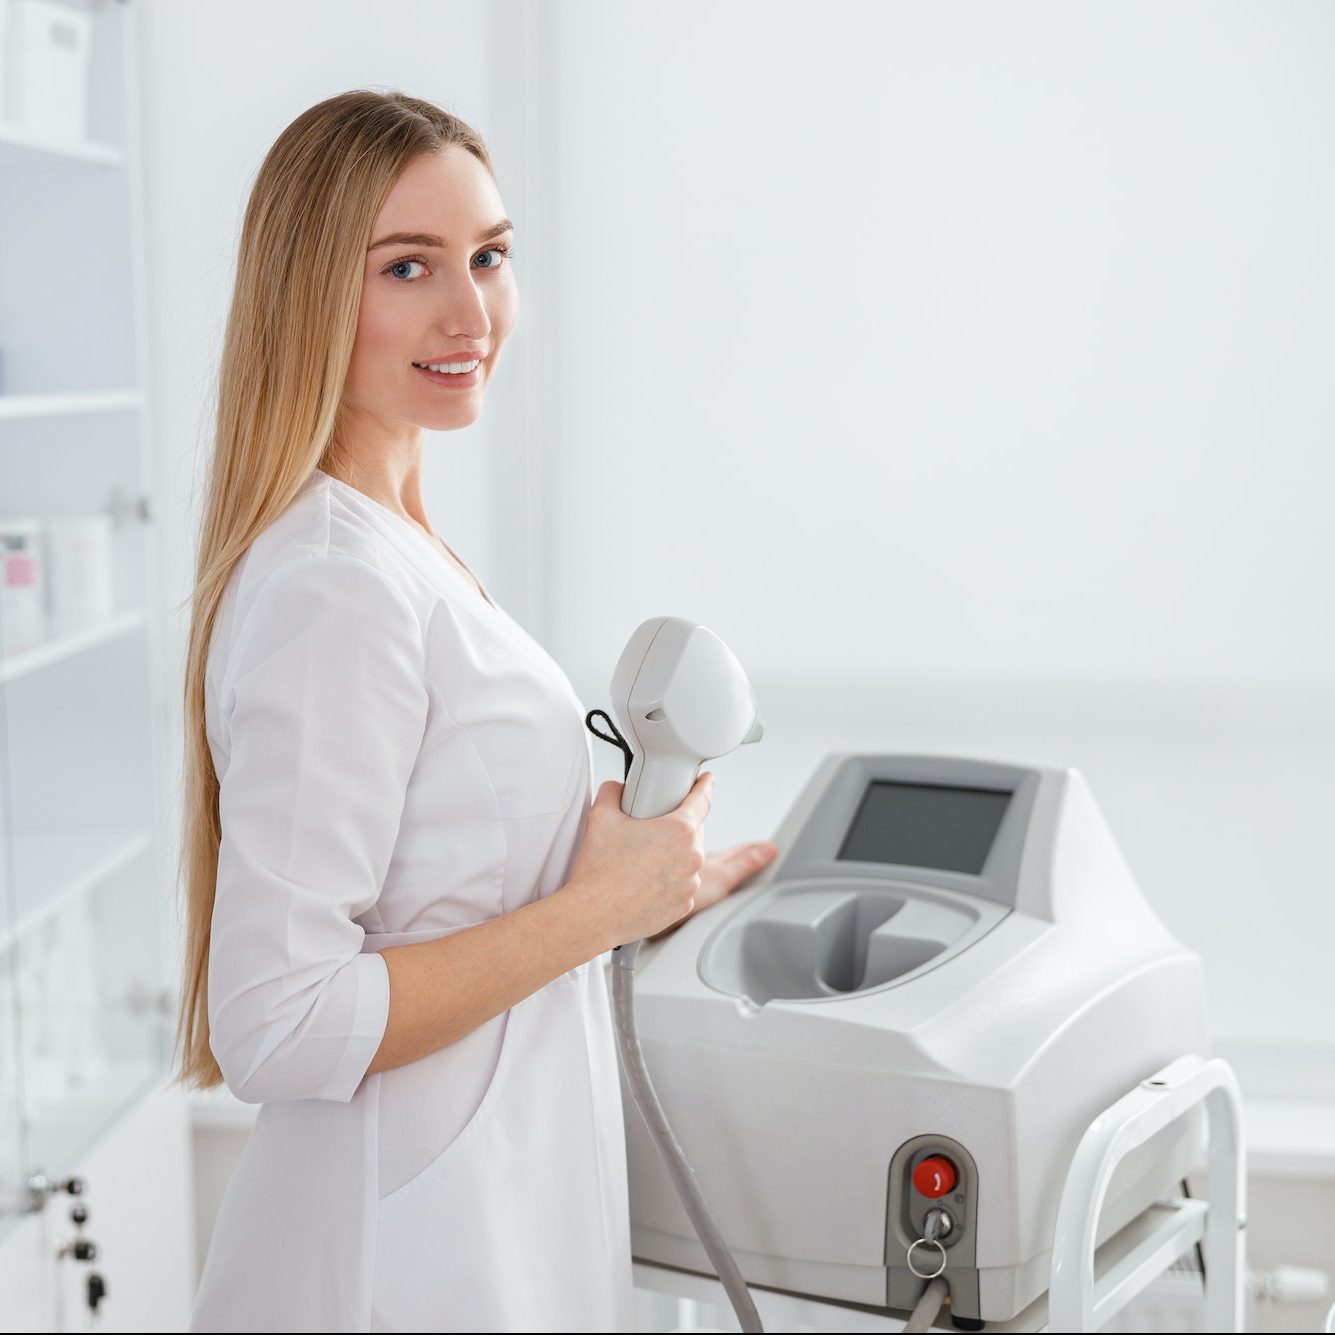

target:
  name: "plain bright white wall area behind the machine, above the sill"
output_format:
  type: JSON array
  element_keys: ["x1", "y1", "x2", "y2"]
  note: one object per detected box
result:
[{"x1": 529, "y1": 0, "x2": 1335, "y2": 1069}]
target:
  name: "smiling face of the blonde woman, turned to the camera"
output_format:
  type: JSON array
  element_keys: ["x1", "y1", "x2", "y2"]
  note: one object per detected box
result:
[{"x1": 343, "y1": 147, "x2": 519, "y2": 433}]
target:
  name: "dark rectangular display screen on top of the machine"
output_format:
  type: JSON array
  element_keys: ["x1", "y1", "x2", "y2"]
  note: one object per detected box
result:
[{"x1": 836, "y1": 780, "x2": 1011, "y2": 876}]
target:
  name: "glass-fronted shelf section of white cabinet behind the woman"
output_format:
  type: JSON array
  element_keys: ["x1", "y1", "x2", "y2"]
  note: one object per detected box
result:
[{"x1": 0, "y1": 0, "x2": 178, "y2": 1313}]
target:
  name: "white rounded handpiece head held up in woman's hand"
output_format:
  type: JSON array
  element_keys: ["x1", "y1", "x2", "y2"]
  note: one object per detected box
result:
[{"x1": 611, "y1": 617, "x2": 765, "y2": 818}]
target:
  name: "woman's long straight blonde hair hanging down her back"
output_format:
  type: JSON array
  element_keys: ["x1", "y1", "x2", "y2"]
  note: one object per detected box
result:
[{"x1": 171, "y1": 89, "x2": 495, "y2": 1089}]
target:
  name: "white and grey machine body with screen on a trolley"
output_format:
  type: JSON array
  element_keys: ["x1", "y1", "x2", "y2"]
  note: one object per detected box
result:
[{"x1": 623, "y1": 753, "x2": 1208, "y2": 1320}]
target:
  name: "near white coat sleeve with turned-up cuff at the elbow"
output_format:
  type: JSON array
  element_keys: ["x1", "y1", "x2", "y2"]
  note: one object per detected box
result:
[{"x1": 208, "y1": 553, "x2": 427, "y2": 1103}]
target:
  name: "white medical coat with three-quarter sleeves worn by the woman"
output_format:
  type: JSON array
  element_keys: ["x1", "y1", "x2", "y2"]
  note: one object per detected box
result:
[{"x1": 190, "y1": 471, "x2": 634, "y2": 1331}]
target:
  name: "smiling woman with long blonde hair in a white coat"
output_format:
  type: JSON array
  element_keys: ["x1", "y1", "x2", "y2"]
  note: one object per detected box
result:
[{"x1": 178, "y1": 91, "x2": 776, "y2": 1331}]
